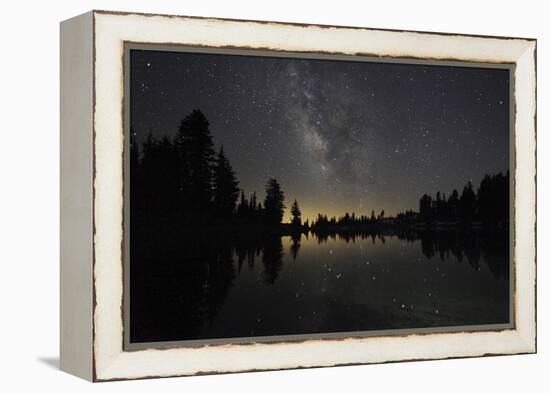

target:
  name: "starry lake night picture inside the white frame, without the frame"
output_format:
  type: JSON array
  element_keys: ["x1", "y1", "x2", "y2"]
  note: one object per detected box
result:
[{"x1": 128, "y1": 47, "x2": 513, "y2": 344}]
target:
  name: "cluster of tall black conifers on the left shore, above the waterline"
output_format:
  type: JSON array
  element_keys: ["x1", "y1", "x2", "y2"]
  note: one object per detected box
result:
[{"x1": 130, "y1": 110, "x2": 285, "y2": 234}]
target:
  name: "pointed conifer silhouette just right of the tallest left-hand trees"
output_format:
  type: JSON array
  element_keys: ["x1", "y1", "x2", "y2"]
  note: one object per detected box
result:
[{"x1": 213, "y1": 147, "x2": 239, "y2": 219}]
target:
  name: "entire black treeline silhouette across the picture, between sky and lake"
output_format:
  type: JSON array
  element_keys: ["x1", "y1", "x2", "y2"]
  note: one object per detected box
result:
[{"x1": 130, "y1": 110, "x2": 510, "y2": 235}]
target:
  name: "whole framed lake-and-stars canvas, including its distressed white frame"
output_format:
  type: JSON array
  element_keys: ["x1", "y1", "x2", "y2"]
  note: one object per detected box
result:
[{"x1": 60, "y1": 11, "x2": 536, "y2": 381}]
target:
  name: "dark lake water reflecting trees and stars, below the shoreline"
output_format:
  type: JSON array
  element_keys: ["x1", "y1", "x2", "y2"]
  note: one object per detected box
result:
[{"x1": 130, "y1": 231, "x2": 510, "y2": 342}]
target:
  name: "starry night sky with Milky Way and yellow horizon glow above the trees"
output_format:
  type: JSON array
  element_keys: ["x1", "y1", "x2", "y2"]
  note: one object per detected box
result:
[{"x1": 130, "y1": 50, "x2": 510, "y2": 224}]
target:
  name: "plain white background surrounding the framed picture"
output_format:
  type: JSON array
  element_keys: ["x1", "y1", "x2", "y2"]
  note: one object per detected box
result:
[{"x1": 0, "y1": 0, "x2": 550, "y2": 393}]
